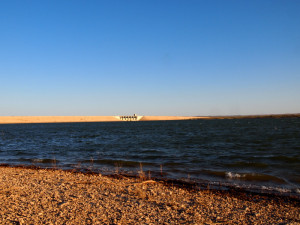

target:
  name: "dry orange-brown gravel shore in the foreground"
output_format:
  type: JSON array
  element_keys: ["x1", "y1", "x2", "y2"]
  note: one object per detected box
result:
[{"x1": 0, "y1": 167, "x2": 300, "y2": 225}]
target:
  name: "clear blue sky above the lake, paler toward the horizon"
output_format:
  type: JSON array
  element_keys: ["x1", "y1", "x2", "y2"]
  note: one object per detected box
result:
[{"x1": 0, "y1": 0, "x2": 300, "y2": 116}]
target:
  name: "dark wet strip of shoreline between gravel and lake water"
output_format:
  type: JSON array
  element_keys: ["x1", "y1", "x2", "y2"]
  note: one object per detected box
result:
[{"x1": 0, "y1": 163, "x2": 300, "y2": 200}]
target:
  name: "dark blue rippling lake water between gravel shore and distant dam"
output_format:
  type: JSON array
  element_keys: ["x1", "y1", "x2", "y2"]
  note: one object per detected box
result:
[{"x1": 0, "y1": 118, "x2": 300, "y2": 194}]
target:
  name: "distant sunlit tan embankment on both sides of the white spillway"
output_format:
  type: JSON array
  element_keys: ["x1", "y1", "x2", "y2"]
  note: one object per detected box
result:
[{"x1": 0, "y1": 113, "x2": 300, "y2": 124}]
